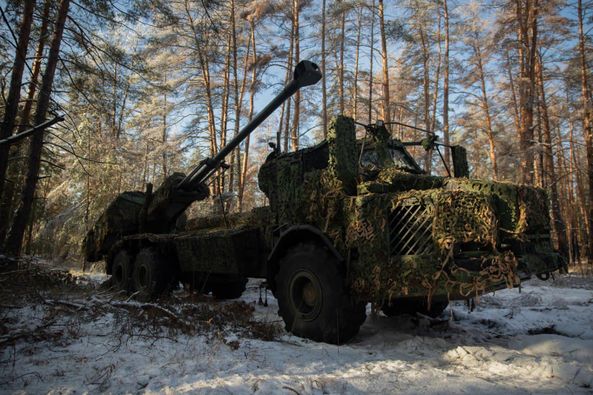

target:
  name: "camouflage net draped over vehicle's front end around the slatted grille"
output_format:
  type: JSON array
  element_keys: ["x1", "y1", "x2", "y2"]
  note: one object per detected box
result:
[{"x1": 347, "y1": 189, "x2": 517, "y2": 303}]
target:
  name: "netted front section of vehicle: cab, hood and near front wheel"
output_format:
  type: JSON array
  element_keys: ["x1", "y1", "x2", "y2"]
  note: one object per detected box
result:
[{"x1": 254, "y1": 117, "x2": 561, "y2": 341}]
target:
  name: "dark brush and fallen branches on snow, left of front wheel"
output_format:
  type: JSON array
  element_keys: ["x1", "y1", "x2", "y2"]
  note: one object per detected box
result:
[{"x1": 0, "y1": 258, "x2": 280, "y2": 365}]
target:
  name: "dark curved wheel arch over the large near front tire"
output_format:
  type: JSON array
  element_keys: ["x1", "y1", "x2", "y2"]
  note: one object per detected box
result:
[{"x1": 267, "y1": 225, "x2": 344, "y2": 291}]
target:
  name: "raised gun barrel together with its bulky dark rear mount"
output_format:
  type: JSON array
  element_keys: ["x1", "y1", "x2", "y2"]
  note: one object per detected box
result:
[{"x1": 84, "y1": 60, "x2": 321, "y2": 262}]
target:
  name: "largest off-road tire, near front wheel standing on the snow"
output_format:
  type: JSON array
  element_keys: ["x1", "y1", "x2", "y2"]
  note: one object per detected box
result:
[{"x1": 275, "y1": 243, "x2": 366, "y2": 344}]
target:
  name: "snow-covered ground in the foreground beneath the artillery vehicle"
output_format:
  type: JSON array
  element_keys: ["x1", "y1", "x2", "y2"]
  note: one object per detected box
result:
[{"x1": 0, "y1": 268, "x2": 593, "y2": 394}]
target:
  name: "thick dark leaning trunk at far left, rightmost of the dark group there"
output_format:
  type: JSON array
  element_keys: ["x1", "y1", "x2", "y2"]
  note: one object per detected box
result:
[{"x1": 6, "y1": 0, "x2": 70, "y2": 256}]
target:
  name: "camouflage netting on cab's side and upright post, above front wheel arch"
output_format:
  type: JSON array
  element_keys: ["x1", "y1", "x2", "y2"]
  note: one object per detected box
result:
[{"x1": 259, "y1": 117, "x2": 358, "y2": 245}]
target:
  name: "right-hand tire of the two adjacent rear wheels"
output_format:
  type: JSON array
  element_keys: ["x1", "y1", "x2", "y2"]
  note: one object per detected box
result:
[{"x1": 132, "y1": 247, "x2": 172, "y2": 301}]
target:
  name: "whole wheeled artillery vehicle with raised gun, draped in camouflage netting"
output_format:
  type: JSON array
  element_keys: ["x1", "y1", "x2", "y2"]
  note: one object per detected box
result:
[{"x1": 86, "y1": 61, "x2": 560, "y2": 343}]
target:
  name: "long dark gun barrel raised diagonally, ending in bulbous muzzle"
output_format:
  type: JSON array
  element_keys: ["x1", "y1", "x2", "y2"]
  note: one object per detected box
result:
[{"x1": 177, "y1": 60, "x2": 321, "y2": 190}]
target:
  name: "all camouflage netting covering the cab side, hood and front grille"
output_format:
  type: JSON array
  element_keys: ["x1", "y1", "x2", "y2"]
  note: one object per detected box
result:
[{"x1": 259, "y1": 114, "x2": 548, "y2": 303}]
